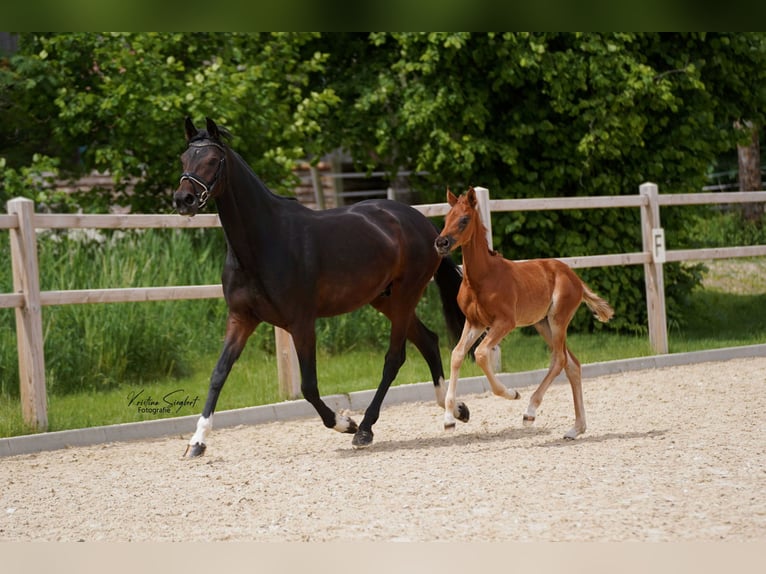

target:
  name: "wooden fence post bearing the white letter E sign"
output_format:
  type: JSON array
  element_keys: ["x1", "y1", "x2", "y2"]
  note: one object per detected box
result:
[{"x1": 639, "y1": 183, "x2": 668, "y2": 354}]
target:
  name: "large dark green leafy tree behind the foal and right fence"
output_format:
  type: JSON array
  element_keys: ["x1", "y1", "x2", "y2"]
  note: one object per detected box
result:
[{"x1": 322, "y1": 33, "x2": 766, "y2": 329}]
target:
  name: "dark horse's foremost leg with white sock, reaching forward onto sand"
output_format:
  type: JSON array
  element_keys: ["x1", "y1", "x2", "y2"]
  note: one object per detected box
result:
[{"x1": 184, "y1": 313, "x2": 259, "y2": 458}]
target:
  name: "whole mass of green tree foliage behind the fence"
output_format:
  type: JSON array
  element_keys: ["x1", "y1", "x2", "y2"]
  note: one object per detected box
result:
[{"x1": 0, "y1": 32, "x2": 766, "y2": 338}]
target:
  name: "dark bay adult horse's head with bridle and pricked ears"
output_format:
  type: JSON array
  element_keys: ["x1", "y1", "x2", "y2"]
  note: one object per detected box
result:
[{"x1": 173, "y1": 117, "x2": 227, "y2": 215}]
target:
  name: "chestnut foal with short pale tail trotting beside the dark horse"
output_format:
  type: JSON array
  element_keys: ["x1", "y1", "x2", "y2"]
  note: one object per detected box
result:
[{"x1": 434, "y1": 188, "x2": 614, "y2": 439}]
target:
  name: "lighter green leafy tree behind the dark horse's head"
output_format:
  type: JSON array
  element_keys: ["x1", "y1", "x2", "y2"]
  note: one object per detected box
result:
[{"x1": 0, "y1": 33, "x2": 337, "y2": 211}]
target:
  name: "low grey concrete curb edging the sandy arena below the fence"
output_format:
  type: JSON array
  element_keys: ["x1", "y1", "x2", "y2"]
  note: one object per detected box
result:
[{"x1": 0, "y1": 344, "x2": 766, "y2": 458}]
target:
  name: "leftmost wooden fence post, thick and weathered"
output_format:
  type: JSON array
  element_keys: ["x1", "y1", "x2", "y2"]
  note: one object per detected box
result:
[{"x1": 8, "y1": 197, "x2": 48, "y2": 431}]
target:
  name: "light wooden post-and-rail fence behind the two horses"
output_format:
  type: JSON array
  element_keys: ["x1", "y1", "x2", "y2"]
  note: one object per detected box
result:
[{"x1": 0, "y1": 183, "x2": 766, "y2": 430}]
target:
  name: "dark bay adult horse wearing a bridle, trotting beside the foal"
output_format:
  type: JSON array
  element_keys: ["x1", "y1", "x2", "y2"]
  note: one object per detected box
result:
[{"x1": 174, "y1": 118, "x2": 469, "y2": 457}]
